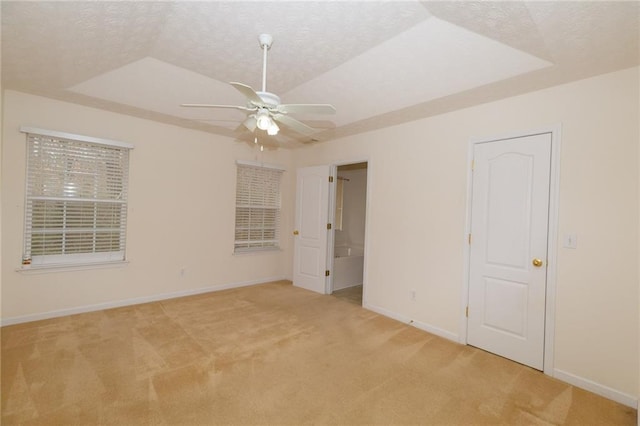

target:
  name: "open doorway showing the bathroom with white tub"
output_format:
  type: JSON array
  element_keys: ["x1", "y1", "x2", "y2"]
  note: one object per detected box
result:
[{"x1": 331, "y1": 162, "x2": 367, "y2": 306}]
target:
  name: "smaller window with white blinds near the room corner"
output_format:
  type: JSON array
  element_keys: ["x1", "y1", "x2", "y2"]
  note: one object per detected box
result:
[{"x1": 235, "y1": 163, "x2": 282, "y2": 252}]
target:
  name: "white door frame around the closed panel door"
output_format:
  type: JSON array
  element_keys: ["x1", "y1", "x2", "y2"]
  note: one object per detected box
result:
[{"x1": 459, "y1": 124, "x2": 562, "y2": 376}]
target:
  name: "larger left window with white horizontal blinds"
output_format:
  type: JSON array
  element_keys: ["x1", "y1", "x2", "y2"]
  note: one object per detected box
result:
[{"x1": 22, "y1": 128, "x2": 132, "y2": 266}]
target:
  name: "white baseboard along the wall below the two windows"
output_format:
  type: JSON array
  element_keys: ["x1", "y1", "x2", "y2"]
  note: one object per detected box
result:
[{"x1": 0, "y1": 276, "x2": 286, "y2": 327}]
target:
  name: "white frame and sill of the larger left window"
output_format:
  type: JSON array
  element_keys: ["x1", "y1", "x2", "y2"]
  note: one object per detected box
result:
[{"x1": 20, "y1": 126, "x2": 134, "y2": 271}]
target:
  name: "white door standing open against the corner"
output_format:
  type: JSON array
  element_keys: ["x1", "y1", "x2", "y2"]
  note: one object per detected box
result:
[{"x1": 293, "y1": 166, "x2": 330, "y2": 293}]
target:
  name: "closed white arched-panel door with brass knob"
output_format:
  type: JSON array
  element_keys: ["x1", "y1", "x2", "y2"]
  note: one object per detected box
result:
[{"x1": 467, "y1": 133, "x2": 551, "y2": 370}]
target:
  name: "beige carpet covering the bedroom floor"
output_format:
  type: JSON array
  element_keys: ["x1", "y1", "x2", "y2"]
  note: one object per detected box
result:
[{"x1": 2, "y1": 282, "x2": 637, "y2": 425}]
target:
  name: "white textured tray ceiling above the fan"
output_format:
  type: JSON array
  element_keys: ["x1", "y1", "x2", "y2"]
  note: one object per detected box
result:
[{"x1": 0, "y1": 1, "x2": 640, "y2": 147}]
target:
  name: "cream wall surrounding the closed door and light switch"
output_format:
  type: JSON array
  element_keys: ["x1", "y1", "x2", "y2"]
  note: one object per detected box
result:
[{"x1": 294, "y1": 69, "x2": 639, "y2": 404}]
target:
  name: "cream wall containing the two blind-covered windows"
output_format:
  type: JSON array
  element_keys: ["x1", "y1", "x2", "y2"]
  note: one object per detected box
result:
[{"x1": 1, "y1": 91, "x2": 295, "y2": 324}]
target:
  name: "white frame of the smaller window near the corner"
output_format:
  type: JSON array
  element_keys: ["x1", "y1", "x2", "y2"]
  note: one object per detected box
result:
[{"x1": 233, "y1": 160, "x2": 285, "y2": 254}]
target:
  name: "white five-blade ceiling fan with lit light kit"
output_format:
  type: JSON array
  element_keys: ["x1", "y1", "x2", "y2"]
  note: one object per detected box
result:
[{"x1": 181, "y1": 34, "x2": 336, "y2": 136}]
